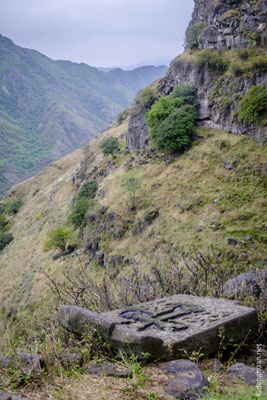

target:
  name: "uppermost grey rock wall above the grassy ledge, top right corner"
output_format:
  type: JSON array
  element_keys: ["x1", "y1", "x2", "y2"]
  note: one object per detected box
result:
[{"x1": 187, "y1": 0, "x2": 267, "y2": 50}]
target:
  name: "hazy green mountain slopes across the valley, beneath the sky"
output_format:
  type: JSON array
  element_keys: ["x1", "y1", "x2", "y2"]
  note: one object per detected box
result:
[{"x1": 0, "y1": 35, "x2": 167, "y2": 196}]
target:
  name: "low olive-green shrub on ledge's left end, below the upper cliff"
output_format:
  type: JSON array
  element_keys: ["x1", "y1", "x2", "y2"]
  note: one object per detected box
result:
[{"x1": 196, "y1": 49, "x2": 229, "y2": 72}]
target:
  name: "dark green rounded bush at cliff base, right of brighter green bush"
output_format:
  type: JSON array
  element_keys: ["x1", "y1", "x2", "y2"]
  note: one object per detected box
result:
[{"x1": 151, "y1": 104, "x2": 197, "y2": 150}]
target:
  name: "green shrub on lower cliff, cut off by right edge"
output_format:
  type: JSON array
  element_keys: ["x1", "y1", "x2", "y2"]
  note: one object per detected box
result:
[{"x1": 238, "y1": 84, "x2": 267, "y2": 124}]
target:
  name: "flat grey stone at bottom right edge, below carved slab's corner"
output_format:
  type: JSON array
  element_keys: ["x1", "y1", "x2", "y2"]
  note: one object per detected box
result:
[{"x1": 227, "y1": 363, "x2": 267, "y2": 385}]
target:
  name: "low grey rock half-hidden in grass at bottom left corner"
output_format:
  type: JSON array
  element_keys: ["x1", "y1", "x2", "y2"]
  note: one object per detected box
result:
[{"x1": 0, "y1": 353, "x2": 42, "y2": 375}]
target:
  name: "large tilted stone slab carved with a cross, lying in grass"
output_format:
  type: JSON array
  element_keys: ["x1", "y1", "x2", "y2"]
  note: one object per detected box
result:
[{"x1": 58, "y1": 295, "x2": 257, "y2": 359}]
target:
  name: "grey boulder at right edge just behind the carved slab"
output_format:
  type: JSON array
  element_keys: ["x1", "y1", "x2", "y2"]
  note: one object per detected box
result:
[{"x1": 223, "y1": 269, "x2": 267, "y2": 298}]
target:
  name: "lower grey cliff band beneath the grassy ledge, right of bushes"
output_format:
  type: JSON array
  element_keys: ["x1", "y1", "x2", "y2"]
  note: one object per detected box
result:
[{"x1": 158, "y1": 56, "x2": 266, "y2": 142}]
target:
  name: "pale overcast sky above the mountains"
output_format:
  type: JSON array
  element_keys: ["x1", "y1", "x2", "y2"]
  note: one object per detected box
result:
[{"x1": 0, "y1": 0, "x2": 194, "y2": 67}]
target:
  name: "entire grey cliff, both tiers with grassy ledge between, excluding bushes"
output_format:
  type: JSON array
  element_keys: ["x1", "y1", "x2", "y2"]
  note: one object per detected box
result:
[{"x1": 127, "y1": 0, "x2": 267, "y2": 149}]
